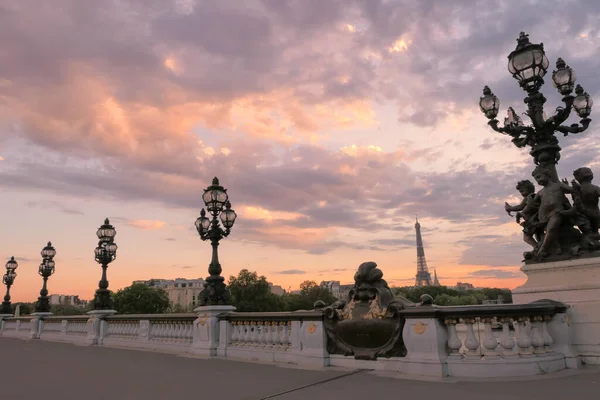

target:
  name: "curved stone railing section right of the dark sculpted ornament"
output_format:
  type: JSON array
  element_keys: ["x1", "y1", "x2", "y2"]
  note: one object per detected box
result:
[{"x1": 394, "y1": 300, "x2": 578, "y2": 377}]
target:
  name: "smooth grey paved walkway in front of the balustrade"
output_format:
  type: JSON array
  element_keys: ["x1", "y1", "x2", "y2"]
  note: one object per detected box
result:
[{"x1": 0, "y1": 338, "x2": 600, "y2": 400}]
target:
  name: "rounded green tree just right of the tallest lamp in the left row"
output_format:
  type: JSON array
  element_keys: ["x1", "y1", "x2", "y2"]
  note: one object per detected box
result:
[{"x1": 228, "y1": 269, "x2": 284, "y2": 312}]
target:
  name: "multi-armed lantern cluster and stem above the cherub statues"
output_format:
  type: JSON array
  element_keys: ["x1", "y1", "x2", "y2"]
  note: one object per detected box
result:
[{"x1": 479, "y1": 32, "x2": 593, "y2": 182}]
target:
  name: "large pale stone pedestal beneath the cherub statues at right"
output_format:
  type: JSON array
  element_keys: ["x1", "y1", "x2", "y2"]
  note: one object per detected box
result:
[{"x1": 512, "y1": 257, "x2": 600, "y2": 364}]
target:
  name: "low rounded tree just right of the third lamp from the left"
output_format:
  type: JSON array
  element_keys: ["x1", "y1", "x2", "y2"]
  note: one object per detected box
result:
[{"x1": 113, "y1": 283, "x2": 170, "y2": 314}]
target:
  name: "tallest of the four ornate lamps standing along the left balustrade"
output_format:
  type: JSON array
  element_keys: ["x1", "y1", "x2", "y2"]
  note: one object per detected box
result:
[{"x1": 195, "y1": 177, "x2": 237, "y2": 306}]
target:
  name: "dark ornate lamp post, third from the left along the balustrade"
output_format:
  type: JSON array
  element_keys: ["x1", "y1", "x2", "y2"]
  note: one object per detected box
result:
[{"x1": 94, "y1": 218, "x2": 117, "y2": 310}]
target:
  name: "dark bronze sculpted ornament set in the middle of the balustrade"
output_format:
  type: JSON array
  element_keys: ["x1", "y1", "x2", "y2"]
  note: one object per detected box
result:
[{"x1": 323, "y1": 262, "x2": 415, "y2": 360}]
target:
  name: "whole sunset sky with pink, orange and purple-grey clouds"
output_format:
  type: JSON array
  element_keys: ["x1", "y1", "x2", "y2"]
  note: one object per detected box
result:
[{"x1": 0, "y1": 0, "x2": 600, "y2": 301}]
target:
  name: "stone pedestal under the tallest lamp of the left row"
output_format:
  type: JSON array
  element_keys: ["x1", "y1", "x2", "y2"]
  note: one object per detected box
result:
[{"x1": 190, "y1": 306, "x2": 235, "y2": 357}]
